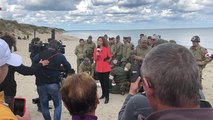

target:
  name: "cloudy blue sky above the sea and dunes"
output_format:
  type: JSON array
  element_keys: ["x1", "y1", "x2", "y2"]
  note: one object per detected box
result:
[{"x1": 0, "y1": 0, "x2": 213, "y2": 30}]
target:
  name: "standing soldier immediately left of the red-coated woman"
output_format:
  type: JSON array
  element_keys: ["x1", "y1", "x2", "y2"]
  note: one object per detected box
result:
[{"x1": 85, "y1": 35, "x2": 96, "y2": 63}]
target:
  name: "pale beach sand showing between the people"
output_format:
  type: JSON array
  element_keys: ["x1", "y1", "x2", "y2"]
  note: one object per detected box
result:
[{"x1": 13, "y1": 34, "x2": 213, "y2": 120}]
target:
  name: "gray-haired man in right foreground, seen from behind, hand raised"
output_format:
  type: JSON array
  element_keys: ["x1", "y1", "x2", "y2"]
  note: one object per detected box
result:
[{"x1": 119, "y1": 43, "x2": 213, "y2": 120}]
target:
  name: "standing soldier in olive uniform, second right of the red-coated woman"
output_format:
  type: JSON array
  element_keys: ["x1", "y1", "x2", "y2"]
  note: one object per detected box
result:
[{"x1": 115, "y1": 35, "x2": 123, "y2": 62}]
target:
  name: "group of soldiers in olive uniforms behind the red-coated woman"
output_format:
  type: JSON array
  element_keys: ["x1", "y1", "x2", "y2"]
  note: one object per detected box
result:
[{"x1": 75, "y1": 34, "x2": 210, "y2": 95}]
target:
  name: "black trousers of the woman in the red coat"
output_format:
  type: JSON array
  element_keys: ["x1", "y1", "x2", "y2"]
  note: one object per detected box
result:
[{"x1": 97, "y1": 72, "x2": 109, "y2": 98}]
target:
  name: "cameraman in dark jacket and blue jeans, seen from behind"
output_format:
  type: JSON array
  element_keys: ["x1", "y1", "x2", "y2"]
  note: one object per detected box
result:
[{"x1": 33, "y1": 40, "x2": 74, "y2": 120}]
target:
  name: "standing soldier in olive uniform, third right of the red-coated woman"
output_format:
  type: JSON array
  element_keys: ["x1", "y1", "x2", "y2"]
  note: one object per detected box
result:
[{"x1": 122, "y1": 37, "x2": 131, "y2": 62}]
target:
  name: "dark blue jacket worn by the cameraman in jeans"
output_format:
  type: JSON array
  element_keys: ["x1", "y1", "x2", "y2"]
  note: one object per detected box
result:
[{"x1": 32, "y1": 49, "x2": 73, "y2": 86}]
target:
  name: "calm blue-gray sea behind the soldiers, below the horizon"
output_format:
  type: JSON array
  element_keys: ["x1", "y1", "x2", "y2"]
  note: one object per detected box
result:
[{"x1": 64, "y1": 28, "x2": 213, "y2": 54}]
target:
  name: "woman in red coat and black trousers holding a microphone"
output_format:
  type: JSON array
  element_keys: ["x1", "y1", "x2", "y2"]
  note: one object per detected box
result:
[{"x1": 93, "y1": 36, "x2": 112, "y2": 104}]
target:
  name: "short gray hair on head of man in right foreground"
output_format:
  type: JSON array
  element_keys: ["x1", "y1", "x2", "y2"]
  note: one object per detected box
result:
[{"x1": 141, "y1": 43, "x2": 200, "y2": 107}]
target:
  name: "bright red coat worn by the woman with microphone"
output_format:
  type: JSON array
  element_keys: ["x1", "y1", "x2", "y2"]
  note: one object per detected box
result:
[{"x1": 93, "y1": 46, "x2": 112, "y2": 73}]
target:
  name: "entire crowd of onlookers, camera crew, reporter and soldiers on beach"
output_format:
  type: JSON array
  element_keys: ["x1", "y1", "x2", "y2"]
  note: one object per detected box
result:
[{"x1": 0, "y1": 30, "x2": 213, "y2": 120}]
